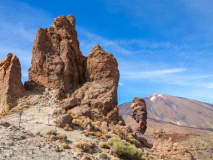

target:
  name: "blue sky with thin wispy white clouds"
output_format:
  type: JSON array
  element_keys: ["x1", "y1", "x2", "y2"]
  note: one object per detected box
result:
[{"x1": 0, "y1": 0, "x2": 213, "y2": 104}]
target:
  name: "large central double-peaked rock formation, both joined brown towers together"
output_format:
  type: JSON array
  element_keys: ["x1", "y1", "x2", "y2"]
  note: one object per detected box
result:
[{"x1": 25, "y1": 15, "x2": 120, "y2": 122}]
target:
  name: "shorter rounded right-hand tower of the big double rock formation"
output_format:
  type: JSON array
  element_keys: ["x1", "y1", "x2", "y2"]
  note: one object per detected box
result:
[{"x1": 62, "y1": 45, "x2": 119, "y2": 121}]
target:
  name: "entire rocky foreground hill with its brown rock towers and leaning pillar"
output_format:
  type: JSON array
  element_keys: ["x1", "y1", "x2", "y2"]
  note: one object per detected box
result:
[{"x1": 0, "y1": 15, "x2": 200, "y2": 160}]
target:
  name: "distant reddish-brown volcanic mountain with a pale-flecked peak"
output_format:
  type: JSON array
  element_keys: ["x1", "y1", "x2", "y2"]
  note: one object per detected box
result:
[{"x1": 118, "y1": 93, "x2": 213, "y2": 129}]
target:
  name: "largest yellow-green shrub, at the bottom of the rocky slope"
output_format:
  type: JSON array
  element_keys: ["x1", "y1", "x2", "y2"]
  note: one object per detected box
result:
[{"x1": 107, "y1": 137, "x2": 142, "y2": 159}]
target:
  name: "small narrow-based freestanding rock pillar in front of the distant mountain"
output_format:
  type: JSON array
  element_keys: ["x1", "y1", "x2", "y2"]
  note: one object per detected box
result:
[{"x1": 130, "y1": 97, "x2": 147, "y2": 134}]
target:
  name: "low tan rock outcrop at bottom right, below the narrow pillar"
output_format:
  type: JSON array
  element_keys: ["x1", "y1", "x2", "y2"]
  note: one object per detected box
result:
[{"x1": 150, "y1": 130, "x2": 194, "y2": 160}]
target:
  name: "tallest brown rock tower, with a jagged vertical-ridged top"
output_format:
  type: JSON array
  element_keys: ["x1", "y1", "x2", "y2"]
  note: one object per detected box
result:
[{"x1": 27, "y1": 15, "x2": 86, "y2": 93}]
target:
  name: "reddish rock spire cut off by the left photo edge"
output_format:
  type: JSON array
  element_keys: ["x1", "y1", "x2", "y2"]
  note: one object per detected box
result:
[{"x1": 0, "y1": 53, "x2": 25, "y2": 114}]
